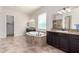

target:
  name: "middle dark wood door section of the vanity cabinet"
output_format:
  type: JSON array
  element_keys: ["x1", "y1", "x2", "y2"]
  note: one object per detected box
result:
[{"x1": 60, "y1": 34, "x2": 69, "y2": 52}]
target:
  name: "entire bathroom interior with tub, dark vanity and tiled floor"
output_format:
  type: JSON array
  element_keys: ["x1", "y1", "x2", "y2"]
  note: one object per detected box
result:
[{"x1": 0, "y1": 6, "x2": 79, "y2": 53}]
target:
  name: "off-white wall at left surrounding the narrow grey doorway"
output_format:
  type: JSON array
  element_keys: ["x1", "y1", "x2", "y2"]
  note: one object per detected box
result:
[{"x1": 0, "y1": 7, "x2": 29, "y2": 37}]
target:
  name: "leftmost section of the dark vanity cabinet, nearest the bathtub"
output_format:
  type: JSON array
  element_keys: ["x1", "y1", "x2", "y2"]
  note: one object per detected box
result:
[{"x1": 47, "y1": 32, "x2": 59, "y2": 48}]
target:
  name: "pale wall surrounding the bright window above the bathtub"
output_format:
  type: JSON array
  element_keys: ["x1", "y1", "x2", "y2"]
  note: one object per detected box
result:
[{"x1": 32, "y1": 6, "x2": 64, "y2": 30}]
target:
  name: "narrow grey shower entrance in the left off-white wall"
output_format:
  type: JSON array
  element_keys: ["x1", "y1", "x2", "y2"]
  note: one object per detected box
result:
[{"x1": 6, "y1": 15, "x2": 14, "y2": 37}]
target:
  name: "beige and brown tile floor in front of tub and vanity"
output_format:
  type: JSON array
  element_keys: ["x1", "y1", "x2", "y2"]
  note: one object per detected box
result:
[{"x1": 0, "y1": 36, "x2": 64, "y2": 53}]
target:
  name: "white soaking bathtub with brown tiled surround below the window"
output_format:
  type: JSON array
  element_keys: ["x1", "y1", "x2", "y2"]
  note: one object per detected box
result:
[{"x1": 26, "y1": 31, "x2": 46, "y2": 46}]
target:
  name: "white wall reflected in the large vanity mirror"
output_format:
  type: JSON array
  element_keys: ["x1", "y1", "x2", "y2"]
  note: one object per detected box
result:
[{"x1": 59, "y1": 7, "x2": 79, "y2": 29}]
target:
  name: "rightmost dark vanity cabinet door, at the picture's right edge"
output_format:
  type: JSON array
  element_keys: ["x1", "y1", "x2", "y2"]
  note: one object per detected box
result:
[{"x1": 70, "y1": 36, "x2": 79, "y2": 53}]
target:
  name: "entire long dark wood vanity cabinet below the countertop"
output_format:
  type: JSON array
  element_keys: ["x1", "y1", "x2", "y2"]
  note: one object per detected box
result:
[{"x1": 47, "y1": 31, "x2": 79, "y2": 53}]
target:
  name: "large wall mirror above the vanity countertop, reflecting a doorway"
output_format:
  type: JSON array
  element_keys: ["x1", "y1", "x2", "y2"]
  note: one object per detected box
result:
[{"x1": 53, "y1": 6, "x2": 79, "y2": 30}]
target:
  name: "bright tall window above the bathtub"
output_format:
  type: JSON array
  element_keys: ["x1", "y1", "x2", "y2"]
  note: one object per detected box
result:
[{"x1": 38, "y1": 13, "x2": 46, "y2": 30}]
